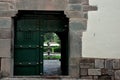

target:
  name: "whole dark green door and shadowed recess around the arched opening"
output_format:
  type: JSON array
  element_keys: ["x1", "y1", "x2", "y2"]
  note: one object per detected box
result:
[{"x1": 14, "y1": 11, "x2": 69, "y2": 76}]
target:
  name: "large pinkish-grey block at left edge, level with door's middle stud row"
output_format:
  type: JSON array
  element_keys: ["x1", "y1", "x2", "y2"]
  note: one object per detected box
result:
[{"x1": 0, "y1": 39, "x2": 11, "y2": 57}]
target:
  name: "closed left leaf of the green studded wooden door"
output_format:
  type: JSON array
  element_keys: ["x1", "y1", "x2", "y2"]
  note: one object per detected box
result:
[{"x1": 14, "y1": 17, "x2": 44, "y2": 75}]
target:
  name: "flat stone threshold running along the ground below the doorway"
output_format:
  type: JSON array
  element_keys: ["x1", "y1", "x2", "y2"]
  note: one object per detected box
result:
[{"x1": 0, "y1": 76, "x2": 93, "y2": 80}]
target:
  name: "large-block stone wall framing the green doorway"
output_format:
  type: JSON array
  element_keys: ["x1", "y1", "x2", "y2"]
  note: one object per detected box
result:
[{"x1": 0, "y1": 0, "x2": 97, "y2": 77}]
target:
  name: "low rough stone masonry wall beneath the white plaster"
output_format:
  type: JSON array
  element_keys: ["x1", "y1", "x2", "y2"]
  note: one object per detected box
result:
[{"x1": 80, "y1": 58, "x2": 120, "y2": 80}]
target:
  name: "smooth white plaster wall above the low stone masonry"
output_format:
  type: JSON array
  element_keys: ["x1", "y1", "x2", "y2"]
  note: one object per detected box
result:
[{"x1": 82, "y1": 0, "x2": 120, "y2": 58}]
